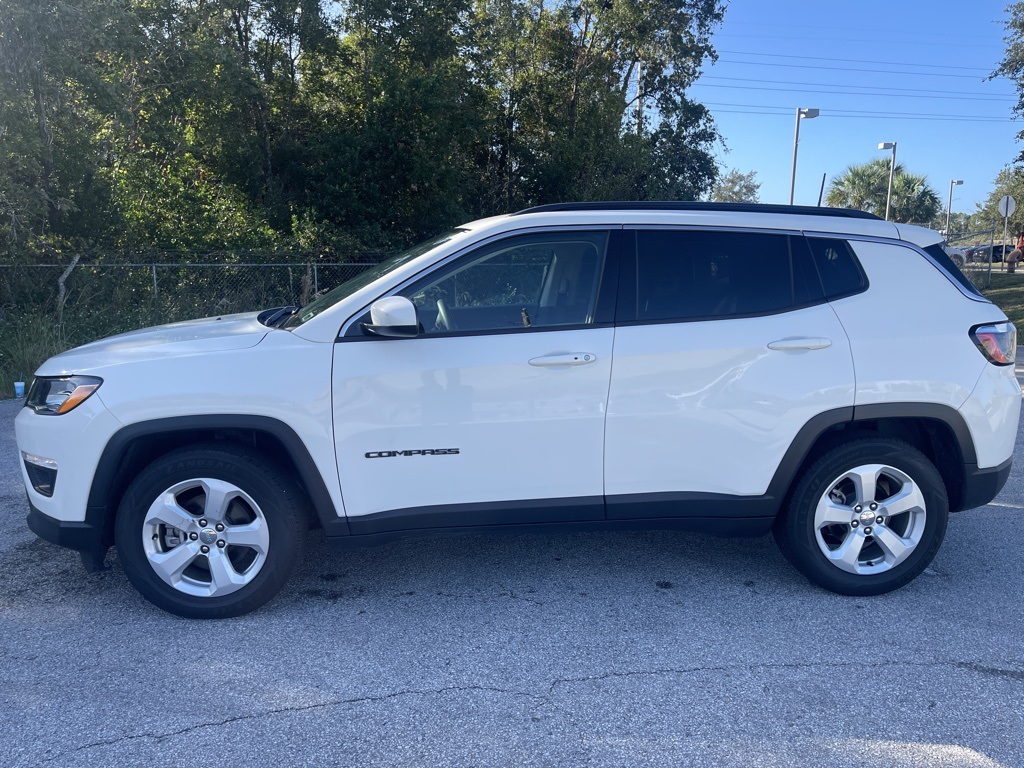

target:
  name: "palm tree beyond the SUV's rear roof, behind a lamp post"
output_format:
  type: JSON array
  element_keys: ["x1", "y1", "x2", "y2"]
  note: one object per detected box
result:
[{"x1": 825, "y1": 158, "x2": 941, "y2": 224}]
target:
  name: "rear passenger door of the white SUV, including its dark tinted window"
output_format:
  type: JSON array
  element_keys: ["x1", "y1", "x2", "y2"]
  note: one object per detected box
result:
[{"x1": 605, "y1": 228, "x2": 854, "y2": 518}]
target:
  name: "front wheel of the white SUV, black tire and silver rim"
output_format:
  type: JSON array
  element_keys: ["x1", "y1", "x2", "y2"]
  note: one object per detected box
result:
[{"x1": 115, "y1": 443, "x2": 308, "y2": 618}]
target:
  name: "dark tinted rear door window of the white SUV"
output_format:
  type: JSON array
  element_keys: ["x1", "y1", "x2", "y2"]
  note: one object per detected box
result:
[{"x1": 624, "y1": 229, "x2": 821, "y2": 322}]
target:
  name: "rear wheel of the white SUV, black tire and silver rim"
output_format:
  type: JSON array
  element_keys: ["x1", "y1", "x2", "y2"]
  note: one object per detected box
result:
[{"x1": 773, "y1": 437, "x2": 949, "y2": 595}]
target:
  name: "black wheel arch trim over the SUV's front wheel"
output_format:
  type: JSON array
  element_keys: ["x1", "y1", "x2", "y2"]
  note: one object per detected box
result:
[{"x1": 85, "y1": 414, "x2": 349, "y2": 547}]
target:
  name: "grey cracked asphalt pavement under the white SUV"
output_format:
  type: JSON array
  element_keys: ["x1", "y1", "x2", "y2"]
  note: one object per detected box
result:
[{"x1": 0, "y1": 400, "x2": 1024, "y2": 767}]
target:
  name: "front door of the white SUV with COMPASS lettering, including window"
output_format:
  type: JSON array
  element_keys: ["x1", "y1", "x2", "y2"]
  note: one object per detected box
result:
[{"x1": 333, "y1": 229, "x2": 613, "y2": 534}]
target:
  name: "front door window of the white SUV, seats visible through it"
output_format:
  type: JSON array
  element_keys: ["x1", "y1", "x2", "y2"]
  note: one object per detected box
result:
[{"x1": 400, "y1": 231, "x2": 608, "y2": 335}]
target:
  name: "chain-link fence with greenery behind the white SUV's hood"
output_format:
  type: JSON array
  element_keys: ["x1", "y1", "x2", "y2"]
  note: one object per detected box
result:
[{"x1": 0, "y1": 254, "x2": 379, "y2": 396}]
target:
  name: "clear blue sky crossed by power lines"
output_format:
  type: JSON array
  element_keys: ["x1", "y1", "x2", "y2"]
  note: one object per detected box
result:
[{"x1": 690, "y1": 0, "x2": 1024, "y2": 213}]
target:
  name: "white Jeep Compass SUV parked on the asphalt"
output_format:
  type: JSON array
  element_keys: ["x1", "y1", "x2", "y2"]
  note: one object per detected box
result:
[{"x1": 16, "y1": 203, "x2": 1021, "y2": 617}]
